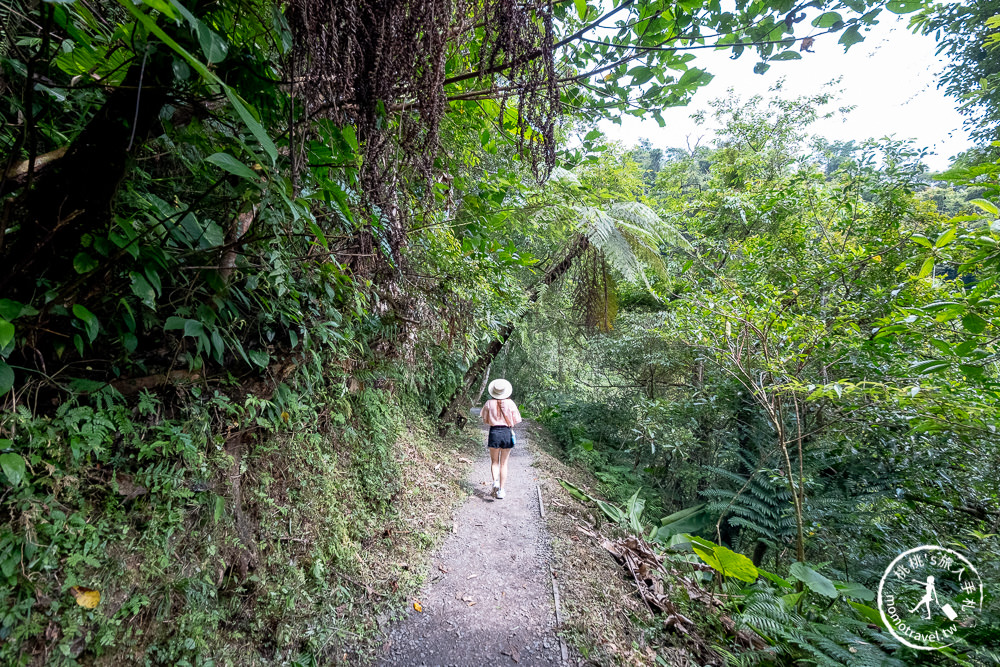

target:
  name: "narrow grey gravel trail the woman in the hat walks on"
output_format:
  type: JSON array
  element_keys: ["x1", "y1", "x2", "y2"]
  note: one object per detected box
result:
[{"x1": 378, "y1": 410, "x2": 568, "y2": 667}]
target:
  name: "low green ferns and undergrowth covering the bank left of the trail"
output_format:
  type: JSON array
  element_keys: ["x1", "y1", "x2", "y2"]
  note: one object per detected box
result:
[{"x1": 0, "y1": 359, "x2": 419, "y2": 665}]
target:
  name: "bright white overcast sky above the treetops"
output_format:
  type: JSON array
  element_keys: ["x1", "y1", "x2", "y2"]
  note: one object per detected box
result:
[{"x1": 601, "y1": 11, "x2": 972, "y2": 171}]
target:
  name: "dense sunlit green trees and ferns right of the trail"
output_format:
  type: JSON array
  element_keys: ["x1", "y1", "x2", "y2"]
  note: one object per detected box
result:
[{"x1": 492, "y1": 91, "x2": 1000, "y2": 664}]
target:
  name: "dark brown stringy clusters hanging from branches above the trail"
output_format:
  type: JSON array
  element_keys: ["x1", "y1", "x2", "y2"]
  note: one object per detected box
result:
[{"x1": 287, "y1": 0, "x2": 559, "y2": 276}]
